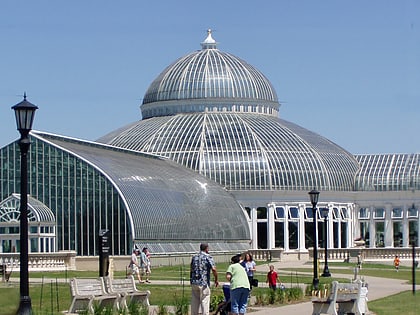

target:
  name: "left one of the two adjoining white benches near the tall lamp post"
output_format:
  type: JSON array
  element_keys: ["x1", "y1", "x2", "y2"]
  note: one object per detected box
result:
[{"x1": 68, "y1": 278, "x2": 120, "y2": 314}]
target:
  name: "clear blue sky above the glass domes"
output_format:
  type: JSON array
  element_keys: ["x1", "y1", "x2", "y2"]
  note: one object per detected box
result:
[{"x1": 0, "y1": 0, "x2": 420, "y2": 154}]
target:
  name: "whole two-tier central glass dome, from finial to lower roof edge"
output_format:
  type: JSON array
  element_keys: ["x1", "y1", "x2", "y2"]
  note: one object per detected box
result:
[{"x1": 99, "y1": 31, "x2": 359, "y2": 191}]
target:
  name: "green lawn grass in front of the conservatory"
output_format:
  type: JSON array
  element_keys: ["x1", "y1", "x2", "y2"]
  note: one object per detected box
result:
[{"x1": 0, "y1": 262, "x2": 420, "y2": 315}]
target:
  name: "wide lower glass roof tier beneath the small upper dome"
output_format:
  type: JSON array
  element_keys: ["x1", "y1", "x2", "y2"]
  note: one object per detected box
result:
[{"x1": 99, "y1": 112, "x2": 359, "y2": 191}]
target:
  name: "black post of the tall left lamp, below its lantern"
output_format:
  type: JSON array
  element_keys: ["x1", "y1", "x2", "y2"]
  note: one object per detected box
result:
[{"x1": 17, "y1": 133, "x2": 32, "y2": 315}]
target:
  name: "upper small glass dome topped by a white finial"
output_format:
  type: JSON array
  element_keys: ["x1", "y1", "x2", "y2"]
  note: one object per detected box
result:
[{"x1": 141, "y1": 30, "x2": 280, "y2": 118}]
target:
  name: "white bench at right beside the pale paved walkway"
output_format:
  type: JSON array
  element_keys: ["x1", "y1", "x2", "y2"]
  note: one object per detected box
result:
[{"x1": 312, "y1": 281, "x2": 367, "y2": 315}]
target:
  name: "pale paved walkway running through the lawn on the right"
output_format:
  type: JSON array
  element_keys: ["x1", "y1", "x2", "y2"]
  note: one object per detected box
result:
[{"x1": 249, "y1": 261, "x2": 419, "y2": 315}]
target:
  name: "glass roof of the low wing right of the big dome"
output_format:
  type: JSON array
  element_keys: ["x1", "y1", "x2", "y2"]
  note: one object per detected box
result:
[{"x1": 355, "y1": 154, "x2": 420, "y2": 191}]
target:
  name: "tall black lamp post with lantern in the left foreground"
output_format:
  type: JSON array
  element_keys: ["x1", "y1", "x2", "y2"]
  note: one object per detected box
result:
[{"x1": 12, "y1": 93, "x2": 38, "y2": 315}]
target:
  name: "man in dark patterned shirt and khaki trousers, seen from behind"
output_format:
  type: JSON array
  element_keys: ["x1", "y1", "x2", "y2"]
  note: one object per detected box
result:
[{"x1": 190, "y1": 243, "x2": 219, "y2": 315}]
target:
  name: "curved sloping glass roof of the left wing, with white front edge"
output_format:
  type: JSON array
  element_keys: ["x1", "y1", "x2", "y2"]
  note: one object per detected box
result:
[{"x1": 33, "y1": 132, "x2": 250, "y2": 242}]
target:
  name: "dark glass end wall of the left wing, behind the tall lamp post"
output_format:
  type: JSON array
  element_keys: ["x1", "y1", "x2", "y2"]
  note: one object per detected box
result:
[{"x1": 0, "y1": 137, "x2": 132, "y2": 256}]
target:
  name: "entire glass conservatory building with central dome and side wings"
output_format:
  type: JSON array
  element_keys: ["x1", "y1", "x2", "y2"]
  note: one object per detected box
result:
[{"x1": 0, "y1": 31, "x2": 420, "y2": 256}]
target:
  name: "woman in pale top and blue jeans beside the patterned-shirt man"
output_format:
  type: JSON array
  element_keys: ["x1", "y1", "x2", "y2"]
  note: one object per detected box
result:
[{"x1": 226, "y1": 255, "x2": 251, "y2": 315}]
